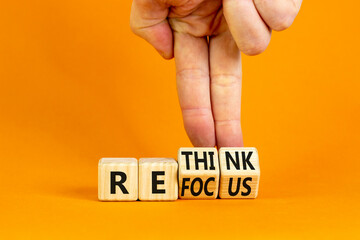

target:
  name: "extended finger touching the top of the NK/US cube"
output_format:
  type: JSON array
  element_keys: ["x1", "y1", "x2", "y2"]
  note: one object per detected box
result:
[{"x1": 210, "y1": 31, "x2": 243, "y2": 148}]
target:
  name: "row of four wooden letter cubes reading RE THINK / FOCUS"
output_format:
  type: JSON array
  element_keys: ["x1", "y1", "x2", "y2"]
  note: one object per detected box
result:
[{"x1": 98, "y1": 147, "x2": 260, "y2": 201}]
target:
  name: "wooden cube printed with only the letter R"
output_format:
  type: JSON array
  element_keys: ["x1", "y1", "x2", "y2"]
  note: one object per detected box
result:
[{"x1": 98, "y1": 158, "x2": 138, "y2": 201}]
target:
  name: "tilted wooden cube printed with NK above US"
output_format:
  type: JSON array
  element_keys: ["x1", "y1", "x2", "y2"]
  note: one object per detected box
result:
[{"x1": 219, "y1": 147, "x2": 260, "y2": 198}]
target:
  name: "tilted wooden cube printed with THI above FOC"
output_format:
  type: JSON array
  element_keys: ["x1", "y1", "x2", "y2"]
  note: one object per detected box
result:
[{"x1": 178, "y1": 148, "x2": 220, "y2": 199}]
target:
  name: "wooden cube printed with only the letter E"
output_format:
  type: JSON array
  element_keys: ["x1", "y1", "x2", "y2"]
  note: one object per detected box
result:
[{"x1": 139, "y1": 158, "x2": 178, "y2": 201}]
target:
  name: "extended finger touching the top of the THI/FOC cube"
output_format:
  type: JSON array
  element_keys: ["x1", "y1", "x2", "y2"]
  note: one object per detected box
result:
[{"x1": 174, "y1": 32, "x2": 215, "y2": 147}]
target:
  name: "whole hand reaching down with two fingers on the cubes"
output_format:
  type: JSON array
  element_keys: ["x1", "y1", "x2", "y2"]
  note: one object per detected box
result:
[{"x1": 130, "y1": 0, "x2": 302, "y2": 147}]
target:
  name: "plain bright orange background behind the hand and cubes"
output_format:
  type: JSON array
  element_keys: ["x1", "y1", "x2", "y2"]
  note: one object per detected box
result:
[{"x1": 0, "y1": 0, "x2": 360, "y2": 239}]
